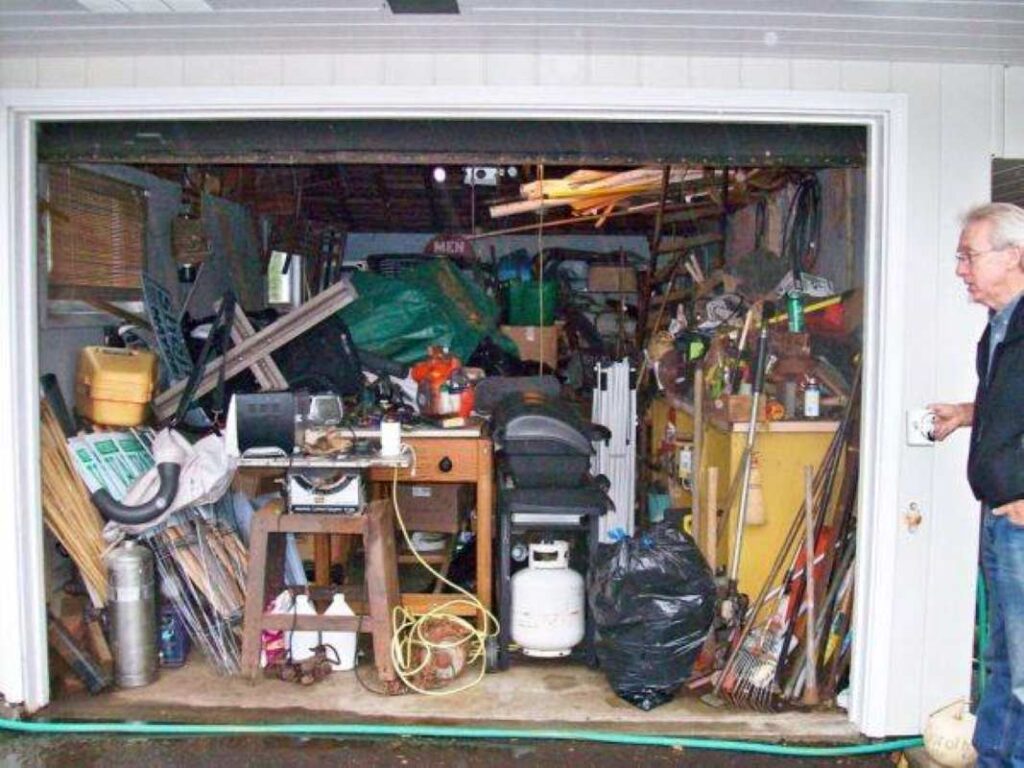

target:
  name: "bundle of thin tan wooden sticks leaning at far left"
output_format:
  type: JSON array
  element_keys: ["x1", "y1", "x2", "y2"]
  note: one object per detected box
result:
[{"x1": 40, "y1": 401, "x2": 106, "y2": 606}]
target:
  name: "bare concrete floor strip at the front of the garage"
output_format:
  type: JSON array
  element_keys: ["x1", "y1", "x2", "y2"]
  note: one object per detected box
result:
[{"x1": 40, "y1": 660, "x2": 860, "y2": 743}]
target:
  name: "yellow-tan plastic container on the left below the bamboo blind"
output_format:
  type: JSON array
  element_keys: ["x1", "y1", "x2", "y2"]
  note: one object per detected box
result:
[{"x1": 75, "y1": 347, "x2": 157, "y2": 427}]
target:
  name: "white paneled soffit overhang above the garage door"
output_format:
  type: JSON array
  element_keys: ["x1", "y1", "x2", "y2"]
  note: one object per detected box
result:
[{"x1": 0, "y1": 0, "x2": 1024, "y2": 65}]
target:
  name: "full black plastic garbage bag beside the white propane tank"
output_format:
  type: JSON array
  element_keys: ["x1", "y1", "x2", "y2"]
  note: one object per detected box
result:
[{"x1": 587, "y1": 523, "x2": 715, "y2": 711}]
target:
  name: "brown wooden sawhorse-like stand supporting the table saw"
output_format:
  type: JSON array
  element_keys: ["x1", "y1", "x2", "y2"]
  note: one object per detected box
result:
[{"x1": 242, "y1": 501, "x2": 399, "y2": 690}]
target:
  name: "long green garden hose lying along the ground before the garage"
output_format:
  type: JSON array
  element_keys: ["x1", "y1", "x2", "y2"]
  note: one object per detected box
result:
[{"x1": 0, "y1": 719, "x2": 924, "y2": 758}]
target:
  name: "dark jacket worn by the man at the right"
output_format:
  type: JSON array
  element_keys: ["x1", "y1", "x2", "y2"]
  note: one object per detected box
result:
[{"x1": 968, "y1": 300, "x2": 1024, "y2": 507}]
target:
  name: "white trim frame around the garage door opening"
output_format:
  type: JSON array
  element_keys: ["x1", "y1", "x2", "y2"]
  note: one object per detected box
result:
[{"x1": 0, "y1": 82, "x2": 913, "y2": 736}]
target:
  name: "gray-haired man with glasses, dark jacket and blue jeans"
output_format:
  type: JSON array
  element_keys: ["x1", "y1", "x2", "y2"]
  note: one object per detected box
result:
[{"x1": 931, "y1": 203, "x2": 1024, "y2": 768}]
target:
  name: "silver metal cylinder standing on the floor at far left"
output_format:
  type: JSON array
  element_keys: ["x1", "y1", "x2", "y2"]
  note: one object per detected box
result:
[{"x1": 106, "y1": 541, "x2": 158, "y2": 688}]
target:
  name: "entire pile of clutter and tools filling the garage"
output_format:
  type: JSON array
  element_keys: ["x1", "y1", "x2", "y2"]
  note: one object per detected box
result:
[{"x1": 41, "y1": 156, "x2": 862, "y2": 711}]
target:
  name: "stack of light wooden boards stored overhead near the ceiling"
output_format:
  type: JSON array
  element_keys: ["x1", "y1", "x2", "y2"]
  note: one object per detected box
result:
[{"x1": 490, "y1": 168, "x2": 703, "y2": 219}]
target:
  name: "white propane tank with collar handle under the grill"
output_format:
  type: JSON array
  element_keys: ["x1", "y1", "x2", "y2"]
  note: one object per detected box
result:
[{"x1": 512, "y1": 542, "x2": 585, "y2": 657}]
